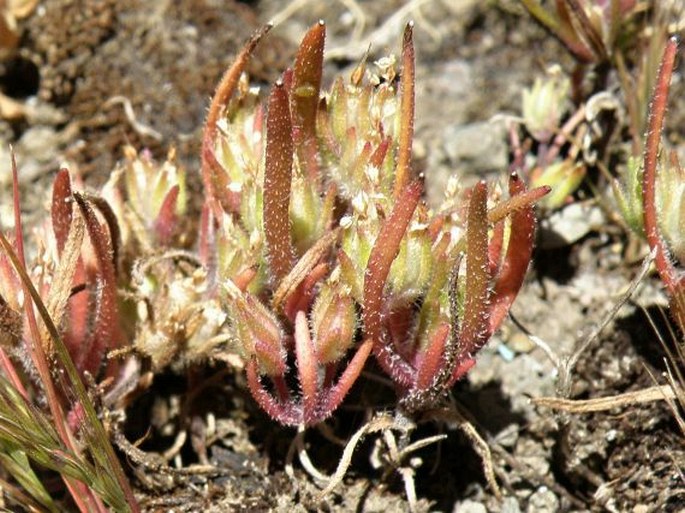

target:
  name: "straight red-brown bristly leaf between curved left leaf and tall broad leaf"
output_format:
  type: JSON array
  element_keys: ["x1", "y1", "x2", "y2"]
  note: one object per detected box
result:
[{"x1": 263, "y1": 82, "x2": 295, "y2": 283}]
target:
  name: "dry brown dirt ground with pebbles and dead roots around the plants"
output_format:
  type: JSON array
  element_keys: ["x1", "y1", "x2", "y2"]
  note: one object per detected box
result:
[{"x1": 0, "y1": 0, "x2": 685, "y2": 513}]
